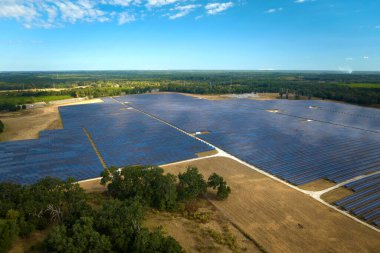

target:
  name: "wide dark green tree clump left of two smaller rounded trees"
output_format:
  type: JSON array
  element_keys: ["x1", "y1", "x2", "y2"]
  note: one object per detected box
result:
[{"x1": 101, "y1": 166, "x2": 177, "y2": 210}]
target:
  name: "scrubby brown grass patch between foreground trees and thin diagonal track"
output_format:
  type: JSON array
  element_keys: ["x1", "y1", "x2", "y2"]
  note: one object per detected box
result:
[{"x1": 144, "y1": 200, "x2": 261, "y2": 253}]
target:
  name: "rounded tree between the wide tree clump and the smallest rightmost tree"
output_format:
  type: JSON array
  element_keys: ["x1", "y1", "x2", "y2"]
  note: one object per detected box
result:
[{"x1": 178, "y1": 167, "x2": 207, "y2": 201}]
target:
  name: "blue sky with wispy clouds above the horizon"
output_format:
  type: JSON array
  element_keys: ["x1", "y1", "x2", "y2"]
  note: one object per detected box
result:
[{"x1": 0, "y1": 0, "x2": 380, "y2": 71}]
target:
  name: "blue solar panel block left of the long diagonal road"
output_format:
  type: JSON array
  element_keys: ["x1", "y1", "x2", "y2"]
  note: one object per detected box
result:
[{"x1": 0, "y1": 98, "x2": 212, "y2": 184}]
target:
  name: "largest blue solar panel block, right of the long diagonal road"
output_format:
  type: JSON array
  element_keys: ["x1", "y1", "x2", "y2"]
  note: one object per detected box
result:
[{"x1": 117, "y1": 94, "x2": 380, "y2": 185}]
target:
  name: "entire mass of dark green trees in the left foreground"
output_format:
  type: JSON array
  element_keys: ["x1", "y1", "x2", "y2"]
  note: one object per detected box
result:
[{"x1": 0, "y1": 166, "x2": 231, "y2": 253}]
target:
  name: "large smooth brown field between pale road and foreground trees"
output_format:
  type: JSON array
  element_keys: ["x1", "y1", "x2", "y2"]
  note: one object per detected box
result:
[{"x1": 163, "y1": 157, "x2": 380, "y2": 253}]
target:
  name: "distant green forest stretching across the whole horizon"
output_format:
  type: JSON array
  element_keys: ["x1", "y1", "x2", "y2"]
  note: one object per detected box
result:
[{"x1": 0, "y1": 71, "x2": 380, "y2": 110}]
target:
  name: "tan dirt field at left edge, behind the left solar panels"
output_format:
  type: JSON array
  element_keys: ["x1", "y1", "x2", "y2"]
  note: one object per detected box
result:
[{"x1": 0, "y1": 99, "x2": 102, "y2": 141}]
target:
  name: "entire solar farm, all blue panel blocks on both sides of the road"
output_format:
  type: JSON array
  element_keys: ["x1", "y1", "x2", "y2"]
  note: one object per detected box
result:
[{"x1": 0, "y1": 94, "x2": 380, "y2": 227}]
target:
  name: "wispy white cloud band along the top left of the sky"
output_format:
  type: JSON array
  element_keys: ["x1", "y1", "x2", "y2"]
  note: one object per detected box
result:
[{"x1": 0, "y1": 0, "x2": 238, "y2": 28}]
